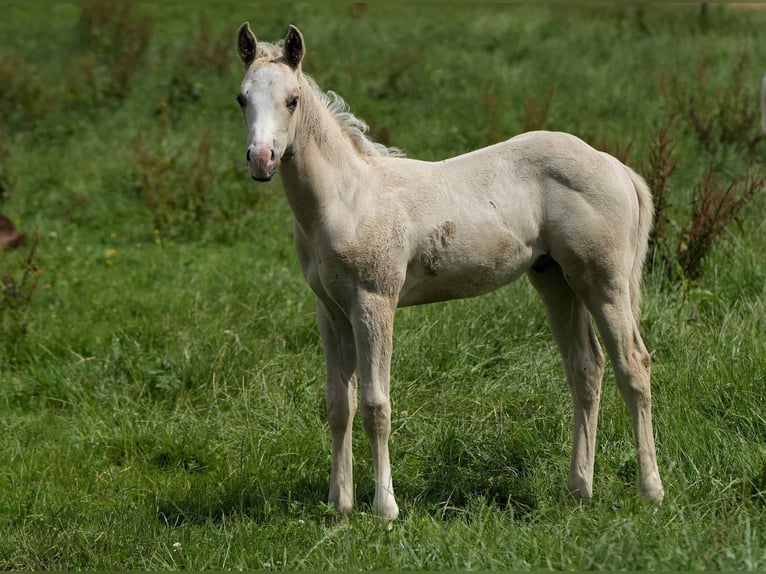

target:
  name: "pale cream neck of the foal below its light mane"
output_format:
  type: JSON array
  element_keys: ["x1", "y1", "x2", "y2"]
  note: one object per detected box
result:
[{"x1": 280, "y1": 78, "x2": 368, "y2": 235}]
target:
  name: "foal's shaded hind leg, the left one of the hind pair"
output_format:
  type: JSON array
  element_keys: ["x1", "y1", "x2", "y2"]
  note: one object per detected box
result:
[{"x1": 528, "y1": 262, "x2": 604, "y2": 499}]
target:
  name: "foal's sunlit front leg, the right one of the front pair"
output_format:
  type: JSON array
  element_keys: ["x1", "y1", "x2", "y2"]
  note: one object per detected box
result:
[{"x1": 351, "y1": 290, "x2": 399, "y2": 520}]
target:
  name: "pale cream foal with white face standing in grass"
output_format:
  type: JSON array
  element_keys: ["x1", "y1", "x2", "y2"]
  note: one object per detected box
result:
[{"x1": 237, "y1": 23, "x2": 663, "y2": 519}]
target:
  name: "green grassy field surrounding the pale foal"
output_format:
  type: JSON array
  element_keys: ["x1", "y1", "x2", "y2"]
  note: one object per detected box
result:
[{"x1": 0, "y1": 3, "x2": 766, "y2": 570}]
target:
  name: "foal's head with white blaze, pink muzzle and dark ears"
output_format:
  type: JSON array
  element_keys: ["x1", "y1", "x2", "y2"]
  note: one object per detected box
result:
[{"x1": 237, "y1": 22, "x2": 305, "y2": 181}]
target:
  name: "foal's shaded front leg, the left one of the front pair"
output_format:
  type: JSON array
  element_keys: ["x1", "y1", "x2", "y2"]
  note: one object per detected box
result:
[{"x1": 317, "y1": 301, "x2": 356, "y2": 514}]
